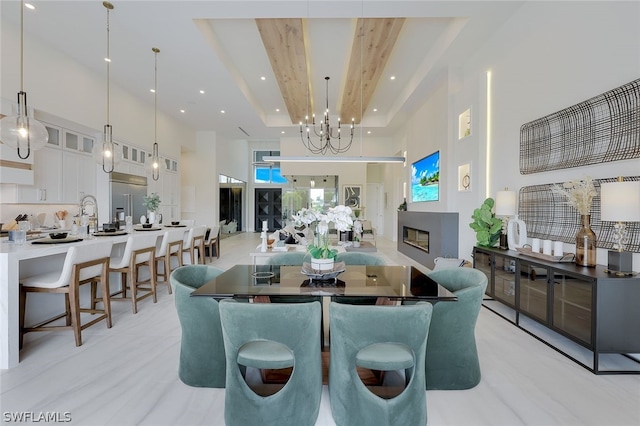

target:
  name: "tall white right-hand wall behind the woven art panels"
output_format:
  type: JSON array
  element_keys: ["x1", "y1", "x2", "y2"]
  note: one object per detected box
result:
[{"x1": 398, "y1": 2, "x2": 640, "y2": 270}]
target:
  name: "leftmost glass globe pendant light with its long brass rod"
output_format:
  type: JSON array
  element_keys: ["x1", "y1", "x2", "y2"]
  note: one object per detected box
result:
[{"x1": 0, "y1": 1, "x2": 49, "y2": 160}]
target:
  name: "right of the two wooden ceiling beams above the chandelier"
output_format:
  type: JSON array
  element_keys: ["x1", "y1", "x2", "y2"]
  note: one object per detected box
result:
[{"x1": 340, "y1": 18, "x2": 405, "y2": 124}]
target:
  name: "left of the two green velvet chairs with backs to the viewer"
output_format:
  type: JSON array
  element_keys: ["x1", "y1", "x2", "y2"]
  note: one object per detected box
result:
[{"x1": 220, "y1": 300, "x2": 322, "y2": 426}]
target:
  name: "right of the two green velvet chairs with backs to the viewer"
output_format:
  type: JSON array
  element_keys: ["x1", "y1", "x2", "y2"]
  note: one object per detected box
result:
[{"x1": 329, "y1": 303, "x2": 433, "y2": 426}]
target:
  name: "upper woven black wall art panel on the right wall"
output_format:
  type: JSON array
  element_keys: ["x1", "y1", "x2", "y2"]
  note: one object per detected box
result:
[{"x1": 520, "y1": 79, "x2": 640, "y2": 174}]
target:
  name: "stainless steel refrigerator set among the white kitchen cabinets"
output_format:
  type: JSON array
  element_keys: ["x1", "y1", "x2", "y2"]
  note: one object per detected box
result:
[{"x1": 110, "y1": 172, "x2": 147, "y2": 224}]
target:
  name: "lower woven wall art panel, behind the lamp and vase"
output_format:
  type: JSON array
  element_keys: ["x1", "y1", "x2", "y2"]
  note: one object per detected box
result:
[{"x1": 518, "y1": 176, "x2": 640, "y2": 253}]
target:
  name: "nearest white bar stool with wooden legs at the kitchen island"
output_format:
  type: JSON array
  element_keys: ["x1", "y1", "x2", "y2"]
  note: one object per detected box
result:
[{"x1": 20, "y1": 241, "x2": 113, "y2": 348}]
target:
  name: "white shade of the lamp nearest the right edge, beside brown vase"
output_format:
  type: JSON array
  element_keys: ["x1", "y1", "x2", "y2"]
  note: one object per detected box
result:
[{"x1": 600, "y1": 182, "x2": 640, "y2": 222}]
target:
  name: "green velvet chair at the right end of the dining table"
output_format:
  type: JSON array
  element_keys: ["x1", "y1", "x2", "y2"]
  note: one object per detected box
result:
[{"x1": 425, "y1": 268, "x2": 487, "y2": 390}]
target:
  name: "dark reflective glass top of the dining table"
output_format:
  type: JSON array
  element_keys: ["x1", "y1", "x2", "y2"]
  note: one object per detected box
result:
[{"x1": 191, "y1": 265, "x2": 457, "y2": 304}]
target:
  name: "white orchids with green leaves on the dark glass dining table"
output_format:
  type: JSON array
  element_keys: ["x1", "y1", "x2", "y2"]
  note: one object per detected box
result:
[{"x1": 292, "y1": 205, "x2": 353, "y2": 259}]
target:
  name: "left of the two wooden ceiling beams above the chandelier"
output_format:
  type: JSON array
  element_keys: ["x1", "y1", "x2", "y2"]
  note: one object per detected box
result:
[{"x1": 256, "y1": 18, "x2": 313, "y2": 124}]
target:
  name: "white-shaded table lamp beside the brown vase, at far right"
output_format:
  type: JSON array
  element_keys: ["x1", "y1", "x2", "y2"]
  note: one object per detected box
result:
[{"x1": 600, "y1": 177, "x2": 640, "y2": 275}]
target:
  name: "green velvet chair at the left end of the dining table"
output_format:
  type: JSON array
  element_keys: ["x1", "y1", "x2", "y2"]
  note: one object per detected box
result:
[{"x1": 170, "y1": 265, "x2": 226, "y2": 388}]
